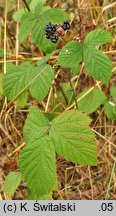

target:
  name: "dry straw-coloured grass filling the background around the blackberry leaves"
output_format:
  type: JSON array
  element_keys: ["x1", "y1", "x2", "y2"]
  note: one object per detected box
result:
[{"x1": 0, "y1": 0, "x2": 116, "y2": 200}]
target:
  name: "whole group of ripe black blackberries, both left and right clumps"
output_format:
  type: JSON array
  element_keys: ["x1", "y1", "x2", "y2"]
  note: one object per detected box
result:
[{"x1": 45, "y1": 21, "x2": 70, "y2": 43}]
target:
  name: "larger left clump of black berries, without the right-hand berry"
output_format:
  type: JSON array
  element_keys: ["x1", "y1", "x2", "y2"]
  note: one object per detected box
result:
[{"x1": 45, "y1": 23, "x2": 59, "y2": 43}]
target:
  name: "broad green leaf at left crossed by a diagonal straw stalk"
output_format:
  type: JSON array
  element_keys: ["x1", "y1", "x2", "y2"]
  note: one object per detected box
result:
[{"x1": 3, "y1": 62, "x2": 54, "y2": 102}]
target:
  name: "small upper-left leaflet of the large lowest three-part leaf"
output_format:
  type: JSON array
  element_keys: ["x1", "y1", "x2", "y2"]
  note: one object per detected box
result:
[{"x1": 23, "y1": 107, "x2": 49, "y2": 143}]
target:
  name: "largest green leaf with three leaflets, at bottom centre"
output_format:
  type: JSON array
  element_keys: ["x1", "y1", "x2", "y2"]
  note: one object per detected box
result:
[{"x1": 19, "y1": 107, "x2": 97, "y2": 199}]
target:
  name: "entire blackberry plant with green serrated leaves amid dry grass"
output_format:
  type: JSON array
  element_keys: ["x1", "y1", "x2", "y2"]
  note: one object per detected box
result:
[{"x1": 3, "y1": 0, "x2": 114, "y2": 199}]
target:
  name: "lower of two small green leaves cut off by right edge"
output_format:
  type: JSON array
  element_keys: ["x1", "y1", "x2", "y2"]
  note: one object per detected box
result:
[{"x1": 105, "y1": 101, "x2": 116, "y2": 120}]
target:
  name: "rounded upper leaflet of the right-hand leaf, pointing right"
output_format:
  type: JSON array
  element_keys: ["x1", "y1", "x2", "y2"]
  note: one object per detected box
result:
[{"x1": 84, "y1": 29, "x2": 112, "y2": 46}]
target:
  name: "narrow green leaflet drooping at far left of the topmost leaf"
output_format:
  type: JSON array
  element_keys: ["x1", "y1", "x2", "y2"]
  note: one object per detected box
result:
[{"x1": 18, "y1": 12, "x2": 36, "y2": 42}]
